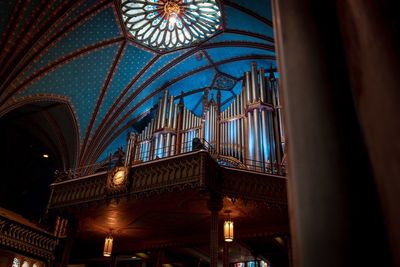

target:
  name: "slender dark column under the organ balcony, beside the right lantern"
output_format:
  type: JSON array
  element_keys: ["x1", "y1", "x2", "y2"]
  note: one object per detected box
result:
[{"x1": 207, "y1": 195, "x2": 222, "y2": 267}]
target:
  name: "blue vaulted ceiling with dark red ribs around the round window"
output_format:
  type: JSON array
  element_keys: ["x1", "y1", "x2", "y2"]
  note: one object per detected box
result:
[{"x1": 0, "y1": 0, "x2": 276, "y2": 166}]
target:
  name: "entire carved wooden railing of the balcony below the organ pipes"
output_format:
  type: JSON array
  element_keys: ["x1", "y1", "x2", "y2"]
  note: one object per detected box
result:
[{"x1": 49, "y1": 150, "x2": 286, "y2": 209}]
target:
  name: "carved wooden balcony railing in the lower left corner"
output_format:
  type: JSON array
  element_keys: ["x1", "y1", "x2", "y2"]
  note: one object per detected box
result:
[{"x1": 0, "y1": 214, "x2": 58, "y2": 261}]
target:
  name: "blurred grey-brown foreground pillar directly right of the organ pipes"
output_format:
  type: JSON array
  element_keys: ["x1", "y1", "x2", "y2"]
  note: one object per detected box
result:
[{"x1": 273, "y1": 0, "x2": 392, "y2": 267}]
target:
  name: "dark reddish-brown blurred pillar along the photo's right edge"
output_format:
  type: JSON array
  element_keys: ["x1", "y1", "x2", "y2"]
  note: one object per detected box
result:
[{"x1": 338, "y1": 0, "x2": 400, "y2": 266}]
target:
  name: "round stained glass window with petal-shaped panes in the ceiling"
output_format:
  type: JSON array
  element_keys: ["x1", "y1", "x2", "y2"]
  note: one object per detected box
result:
[{"x1": 121, "y1": 0, "x2": 221, "y2": 50}]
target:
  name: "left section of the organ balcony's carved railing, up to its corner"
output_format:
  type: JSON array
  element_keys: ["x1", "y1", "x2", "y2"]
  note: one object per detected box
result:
[{"x1": 49, "y1": 150, "x2": 218, "y2": 209}]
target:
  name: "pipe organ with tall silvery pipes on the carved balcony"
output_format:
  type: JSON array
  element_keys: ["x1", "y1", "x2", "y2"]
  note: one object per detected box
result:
[{"x1": 127, "y1": 63, "x2": 285, "y2": 176}]
